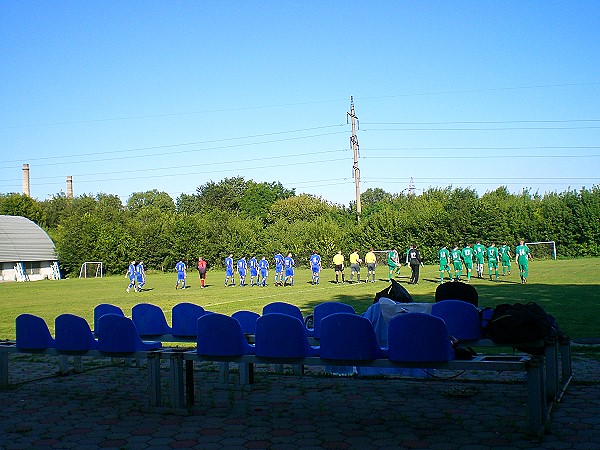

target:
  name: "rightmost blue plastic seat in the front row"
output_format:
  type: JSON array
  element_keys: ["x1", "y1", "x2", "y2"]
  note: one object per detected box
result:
[{"x1": 388, "y1": 313, "x2": 454, "y2": 362}]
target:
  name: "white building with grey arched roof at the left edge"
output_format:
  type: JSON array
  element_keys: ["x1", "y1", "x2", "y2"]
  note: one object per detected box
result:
[{"x1": 0, "y1": 215, "x2": 60, "y2": 281}]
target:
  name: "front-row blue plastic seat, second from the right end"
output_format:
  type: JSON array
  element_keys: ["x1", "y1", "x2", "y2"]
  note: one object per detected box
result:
[{"x1": 320, "y1": 313, "x2": 387, "y2": 361}]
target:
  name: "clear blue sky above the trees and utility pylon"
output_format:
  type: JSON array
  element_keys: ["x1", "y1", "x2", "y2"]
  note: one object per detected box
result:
[{"x1": 0, "y1": 0, "x2": 600, "y2": 205}]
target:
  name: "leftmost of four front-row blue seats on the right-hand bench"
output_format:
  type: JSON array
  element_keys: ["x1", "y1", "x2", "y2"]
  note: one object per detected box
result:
[{"x1": 196, "y1": 313, "x2": 254, "y2": 356}]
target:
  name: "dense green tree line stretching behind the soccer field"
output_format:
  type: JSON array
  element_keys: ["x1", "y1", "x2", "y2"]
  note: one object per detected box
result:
[{"x1": 0, "y1": 177, "x2": 600, "y2": 276}]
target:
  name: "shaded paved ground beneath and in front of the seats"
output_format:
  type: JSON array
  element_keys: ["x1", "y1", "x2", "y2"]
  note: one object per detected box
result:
[{"x1": 0, "y1": 355, "x2": 600, "y2": 450}]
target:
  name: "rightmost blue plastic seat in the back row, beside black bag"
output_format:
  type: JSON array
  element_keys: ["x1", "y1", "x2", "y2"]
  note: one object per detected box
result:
[{"x1": 431, "y1": 300, "x2": 483, "y2": 340}]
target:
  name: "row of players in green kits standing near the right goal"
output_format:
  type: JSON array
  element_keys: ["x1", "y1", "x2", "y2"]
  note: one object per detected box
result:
[{"x1": 438, "y1": 240, "x2": 532, "y2": 284}]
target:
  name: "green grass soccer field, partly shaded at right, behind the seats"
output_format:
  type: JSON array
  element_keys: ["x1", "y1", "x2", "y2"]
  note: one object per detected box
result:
[{"x1": 0, "y1": 258, "x2": 600, "y2": 339}]
